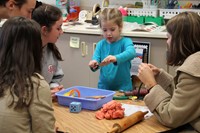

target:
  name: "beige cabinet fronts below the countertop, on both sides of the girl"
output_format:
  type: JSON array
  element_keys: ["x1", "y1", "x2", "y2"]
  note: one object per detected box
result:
[{"x1": 56, "y1": 33, "x2": 168, "y2": 88}]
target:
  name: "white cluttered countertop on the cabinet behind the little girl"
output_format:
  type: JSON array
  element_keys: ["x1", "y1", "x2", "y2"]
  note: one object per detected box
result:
[{"x1": 62, "y1": 22, "x2": 167, "y2": 39}]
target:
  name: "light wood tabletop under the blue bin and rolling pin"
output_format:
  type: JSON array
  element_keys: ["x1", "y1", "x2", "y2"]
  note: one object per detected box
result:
[{"x1": 53, "y1": 100, "x2": 169, "y2": 133}]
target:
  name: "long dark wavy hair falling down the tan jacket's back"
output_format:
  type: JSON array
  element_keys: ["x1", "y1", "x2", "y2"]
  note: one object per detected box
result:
[{"x1": 0, "y1": 17, "x2": 42, "y2": 108}]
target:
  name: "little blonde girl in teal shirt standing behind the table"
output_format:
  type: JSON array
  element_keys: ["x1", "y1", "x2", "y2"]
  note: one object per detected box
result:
[{"x1": 89, "y1": 8, "x2": 136, "y2": 91}]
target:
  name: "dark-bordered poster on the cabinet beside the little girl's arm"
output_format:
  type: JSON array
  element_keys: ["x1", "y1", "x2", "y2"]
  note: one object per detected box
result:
[{"x1": 130, "y1": 41, "x2": 151, "y2": 76}]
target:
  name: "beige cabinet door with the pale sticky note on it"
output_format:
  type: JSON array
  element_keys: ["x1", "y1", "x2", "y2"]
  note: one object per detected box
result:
[{"x1": 57, "y1": 33, "x2": 89, "y2": 88}]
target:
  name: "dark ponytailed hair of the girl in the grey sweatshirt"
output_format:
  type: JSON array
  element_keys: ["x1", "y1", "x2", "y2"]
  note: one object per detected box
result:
[{"x1": 32, "y1": 3, "x2": 63, "y2": 61}]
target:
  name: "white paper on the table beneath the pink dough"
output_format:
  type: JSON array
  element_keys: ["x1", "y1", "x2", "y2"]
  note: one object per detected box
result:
[{"x1": 122, "y1": 103, "x2": 153, "y2": 119}]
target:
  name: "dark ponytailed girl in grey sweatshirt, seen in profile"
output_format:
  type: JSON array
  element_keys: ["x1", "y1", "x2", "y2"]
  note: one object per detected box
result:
[{"x1": 32, "y1": 4, "x2": 64, "y2": 96}]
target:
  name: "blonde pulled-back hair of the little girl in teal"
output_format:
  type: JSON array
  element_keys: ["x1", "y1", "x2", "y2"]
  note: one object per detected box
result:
[{"x1": 99, "y1": 8, "x2": 123, "y2": 27}]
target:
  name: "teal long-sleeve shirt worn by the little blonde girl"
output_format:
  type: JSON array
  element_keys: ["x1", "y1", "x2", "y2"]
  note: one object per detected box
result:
[{"x1": 92, "y1": 37, "x2": 136, "y2": 91}]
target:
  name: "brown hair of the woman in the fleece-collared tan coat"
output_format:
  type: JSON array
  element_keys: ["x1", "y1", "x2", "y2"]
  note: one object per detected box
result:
[{"x1": 166, "y1": 12, "x2": 200, "y2": 66}]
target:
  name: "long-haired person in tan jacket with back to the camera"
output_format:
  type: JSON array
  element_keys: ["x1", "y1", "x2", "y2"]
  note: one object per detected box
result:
[{"x1": 0, "y1": 17, "x2": 55, "y2": 133}]
